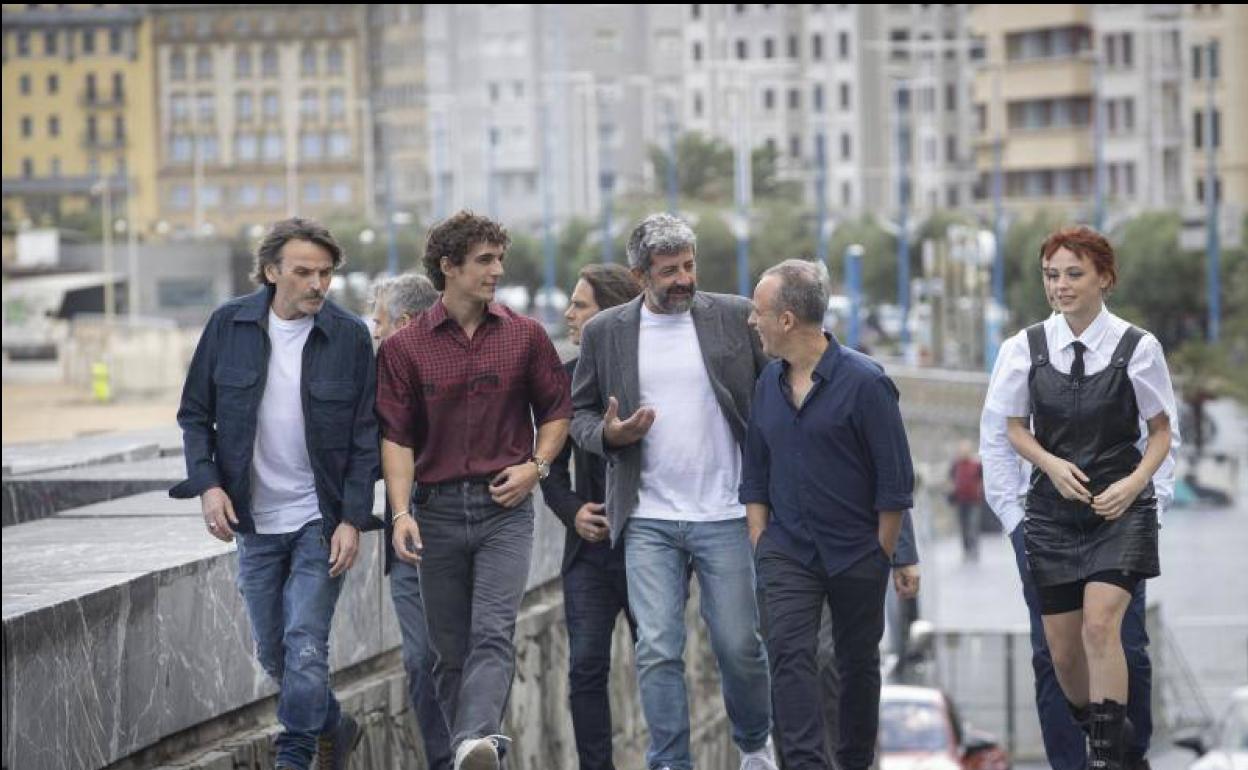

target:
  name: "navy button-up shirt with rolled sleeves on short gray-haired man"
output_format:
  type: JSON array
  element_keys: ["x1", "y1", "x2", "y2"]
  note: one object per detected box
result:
[{"x1": 740, "y1": 336, "x2": 915, "y2": 575}]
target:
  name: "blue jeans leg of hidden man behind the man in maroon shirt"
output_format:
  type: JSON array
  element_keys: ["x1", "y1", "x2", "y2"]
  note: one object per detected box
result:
[{"x1": 391, "y1": 559, "x2": 452, "y2": 770}]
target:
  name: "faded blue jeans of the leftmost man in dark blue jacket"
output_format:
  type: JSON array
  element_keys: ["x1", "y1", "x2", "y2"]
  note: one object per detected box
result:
[{"x1": 237, "y1": 519, "x2": 342, "y2": 770}]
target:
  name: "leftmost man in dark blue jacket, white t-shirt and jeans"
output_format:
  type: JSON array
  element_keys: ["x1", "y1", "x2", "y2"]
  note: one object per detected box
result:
[{"x1": 170, "y1": 218, "x2": 379, "y2": 770}]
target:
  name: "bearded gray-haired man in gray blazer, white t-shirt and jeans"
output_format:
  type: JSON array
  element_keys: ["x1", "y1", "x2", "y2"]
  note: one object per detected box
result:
[{"x1": 572, "y1": 213, "x2": 775, "y2": 770}]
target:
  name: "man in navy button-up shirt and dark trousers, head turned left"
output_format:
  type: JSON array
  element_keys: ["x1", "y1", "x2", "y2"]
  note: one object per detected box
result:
[{"x1": 740, "y1": 260, "x2": 915, "y2": 770}]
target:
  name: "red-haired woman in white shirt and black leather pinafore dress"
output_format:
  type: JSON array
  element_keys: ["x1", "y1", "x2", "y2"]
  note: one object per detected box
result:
[{"x1": 985, "y1": 226, "x2": 1177, "y2": 770}]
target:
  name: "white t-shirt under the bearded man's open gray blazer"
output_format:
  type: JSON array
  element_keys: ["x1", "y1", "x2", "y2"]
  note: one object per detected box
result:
[{"x1": 633, "y1": 305, "x2": 745, "y2": 522}]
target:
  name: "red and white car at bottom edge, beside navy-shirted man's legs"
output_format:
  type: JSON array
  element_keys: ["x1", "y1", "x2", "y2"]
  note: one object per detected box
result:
[{"x1": 880, "y1": 685, "x2": 1010, "y2": 770}]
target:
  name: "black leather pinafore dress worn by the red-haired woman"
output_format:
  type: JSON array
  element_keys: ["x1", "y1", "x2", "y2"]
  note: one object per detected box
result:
[{"x1": 1023, "y1": 323, "x2": 1161, "y2": 587}]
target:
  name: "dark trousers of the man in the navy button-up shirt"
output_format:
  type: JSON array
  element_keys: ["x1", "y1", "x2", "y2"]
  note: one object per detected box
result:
[{"x1": 755, "y1": 534, "x2": 890, "y2": 770}]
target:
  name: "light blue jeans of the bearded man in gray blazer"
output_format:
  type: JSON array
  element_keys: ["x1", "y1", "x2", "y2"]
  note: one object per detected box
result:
[{"x1": 624, "y1": 518, "x2": 771, "y2": 770}]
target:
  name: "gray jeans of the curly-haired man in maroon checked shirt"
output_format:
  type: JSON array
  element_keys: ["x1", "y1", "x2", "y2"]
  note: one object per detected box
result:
[{"x1": 414, "y1": 480, "x2": 533, "y2": 749}]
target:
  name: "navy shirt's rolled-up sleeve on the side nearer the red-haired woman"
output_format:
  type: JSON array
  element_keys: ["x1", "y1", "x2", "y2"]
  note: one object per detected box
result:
[{"x1": 857, "y1": 374, "x2": 915, "y2": 510}]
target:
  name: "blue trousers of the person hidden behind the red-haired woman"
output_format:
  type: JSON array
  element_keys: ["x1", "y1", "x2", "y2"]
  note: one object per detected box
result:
[{"x1": 1010, "y1": 525, "x2": 1153, "y2": 770}]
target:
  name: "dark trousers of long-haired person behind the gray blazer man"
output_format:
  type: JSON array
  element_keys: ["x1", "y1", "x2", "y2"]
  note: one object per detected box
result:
[{"x1": 563, "y1": 558, "x2": 636, "y2": 770}]
